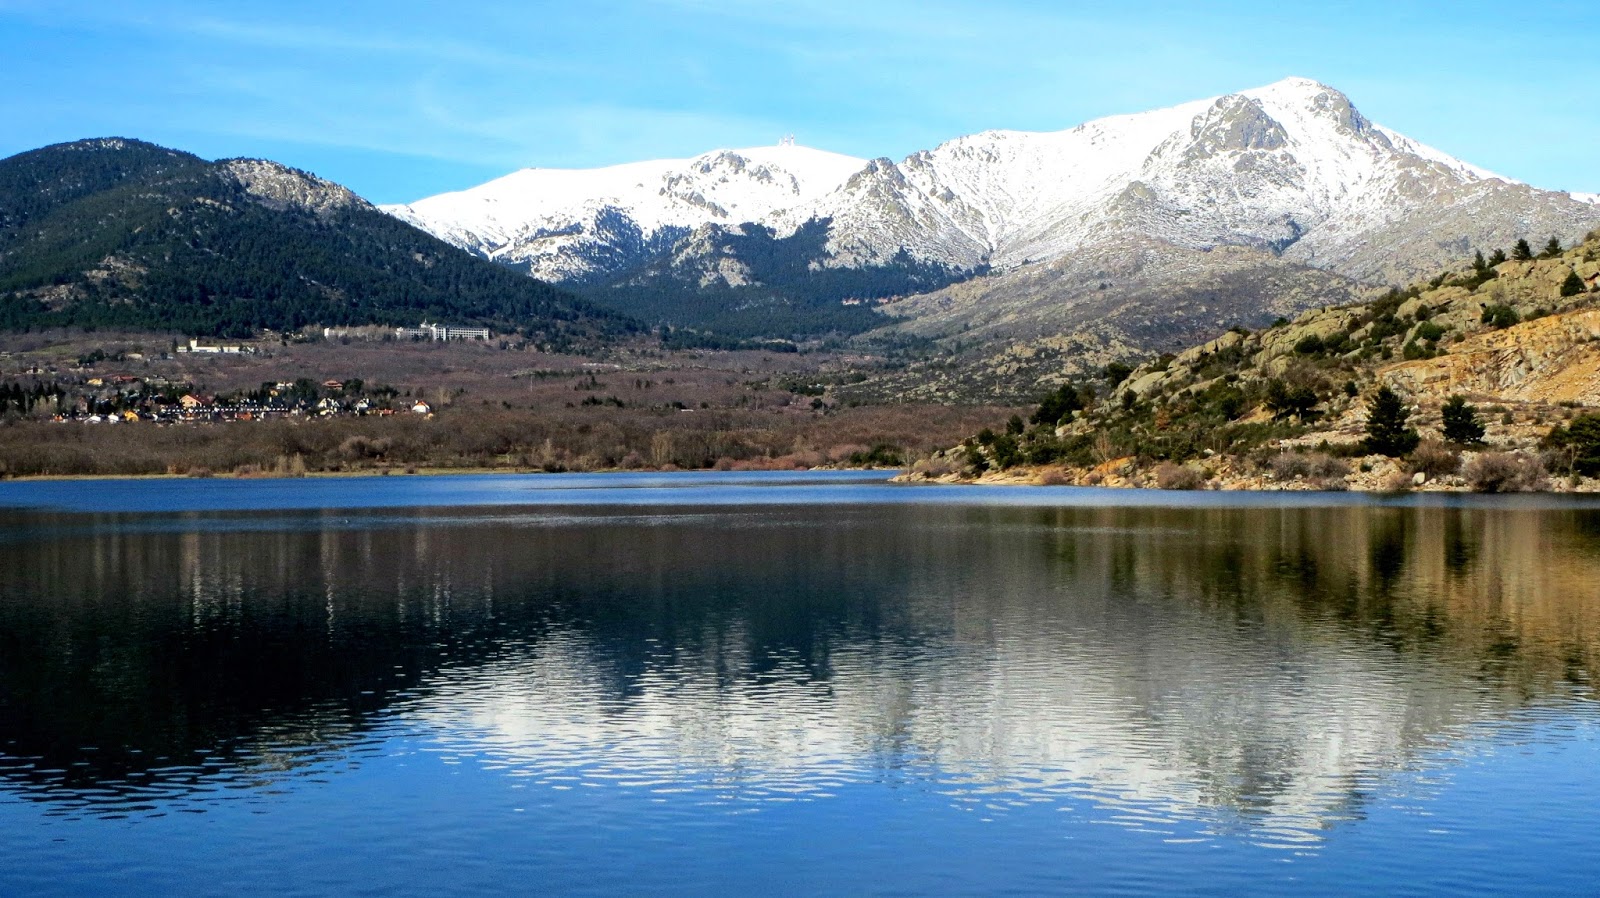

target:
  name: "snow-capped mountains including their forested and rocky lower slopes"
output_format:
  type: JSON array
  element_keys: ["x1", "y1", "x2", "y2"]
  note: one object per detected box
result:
[{"x1": 384, "y1": 78, "x2": 1600, "y2": 366}]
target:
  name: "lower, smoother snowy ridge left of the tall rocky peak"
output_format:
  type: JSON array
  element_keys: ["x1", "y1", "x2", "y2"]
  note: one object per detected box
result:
[{"x1": 384, "y1": 142, "x2": 866, "y2": 280}]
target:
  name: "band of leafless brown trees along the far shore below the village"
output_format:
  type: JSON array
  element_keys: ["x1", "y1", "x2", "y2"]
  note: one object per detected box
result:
[{"x1": 0, "y1": 405, "x2": 994, "y2": 477}]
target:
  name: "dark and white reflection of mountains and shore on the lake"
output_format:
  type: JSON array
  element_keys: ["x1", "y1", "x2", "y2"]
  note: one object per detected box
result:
[{"x1": 0, "y1": 506, "x2": 1600, "y2": 845}]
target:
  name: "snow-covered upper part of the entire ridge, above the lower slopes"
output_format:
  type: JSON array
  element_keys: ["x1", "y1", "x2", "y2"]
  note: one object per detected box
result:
[{"x1": 386, "y1": 78, "x2": 1600, "y2": 291}]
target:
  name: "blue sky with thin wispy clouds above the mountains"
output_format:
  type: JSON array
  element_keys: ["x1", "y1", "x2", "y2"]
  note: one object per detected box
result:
[{"x1": 0, "y1": 0, "x2": 1600, "y2": 202}]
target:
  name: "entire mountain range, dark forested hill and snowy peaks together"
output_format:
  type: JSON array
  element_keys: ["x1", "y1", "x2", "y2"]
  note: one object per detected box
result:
[{"x1": 0, "y1": 78, "x2": 1600, "y2": 387}]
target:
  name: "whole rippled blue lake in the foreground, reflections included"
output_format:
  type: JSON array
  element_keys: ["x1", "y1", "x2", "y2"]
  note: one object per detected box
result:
[{"x1": 0, "y1": 472, "x2": 1600, "y2": 895}]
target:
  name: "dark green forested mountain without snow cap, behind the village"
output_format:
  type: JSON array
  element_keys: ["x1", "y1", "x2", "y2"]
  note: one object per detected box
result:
[{"x1": 0, "y1": 138, "x2": 635, "y2": 339}]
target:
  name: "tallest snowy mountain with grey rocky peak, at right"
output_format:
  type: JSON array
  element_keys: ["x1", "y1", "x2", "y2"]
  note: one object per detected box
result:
[{"x1": 779, "y1": 78, "x2": 1595, "y2": 282}]
